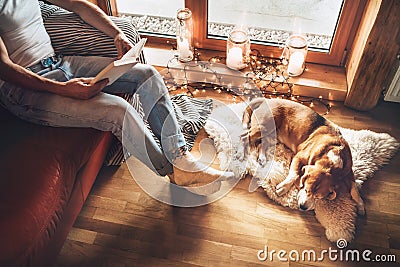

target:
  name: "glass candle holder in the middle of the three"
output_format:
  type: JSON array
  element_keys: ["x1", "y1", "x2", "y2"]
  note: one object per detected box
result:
[{"x1": 226, "y1": 30, "x2": 250, "y2": 70}]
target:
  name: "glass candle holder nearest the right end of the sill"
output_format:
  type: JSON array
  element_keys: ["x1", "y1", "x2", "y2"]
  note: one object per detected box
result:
[{"x1": 284, "y1": 34, "x2": 307, "y2": 76}]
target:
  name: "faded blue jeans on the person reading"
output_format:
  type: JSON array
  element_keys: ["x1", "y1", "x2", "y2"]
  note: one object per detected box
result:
[{"x1": 0, "y1": 56, "x2": 185, "y2": 175}]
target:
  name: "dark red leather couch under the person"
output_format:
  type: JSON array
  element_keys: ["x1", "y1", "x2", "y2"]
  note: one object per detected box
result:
[{"x1": 0, "y1": 105, "x2": 113, "y2": 266}]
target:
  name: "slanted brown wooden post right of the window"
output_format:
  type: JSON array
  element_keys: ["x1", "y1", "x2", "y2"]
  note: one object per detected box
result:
[{"x1": 345, "y1": 0, "x2": 400, "y2": 110}]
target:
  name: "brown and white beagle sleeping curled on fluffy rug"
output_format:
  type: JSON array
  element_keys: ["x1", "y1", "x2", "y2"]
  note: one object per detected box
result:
[{"x1": 242, "y1": 98, "x2": 365, "y2": 214}]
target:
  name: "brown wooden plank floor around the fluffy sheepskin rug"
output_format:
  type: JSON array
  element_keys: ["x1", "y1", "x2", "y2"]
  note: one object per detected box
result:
[{"x1": 56, "y1": 97, "x2": 400, "y2": 266}]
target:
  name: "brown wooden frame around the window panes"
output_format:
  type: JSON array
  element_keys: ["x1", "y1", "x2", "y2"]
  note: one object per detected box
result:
[{"x1": 97, "y1": 0, "x2": 367, "y2": 66}]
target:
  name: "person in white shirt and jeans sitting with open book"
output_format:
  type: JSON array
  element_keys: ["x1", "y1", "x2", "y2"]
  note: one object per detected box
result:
[{"x1": 0, "y1": 0, "x2": 233, "y2": 194}]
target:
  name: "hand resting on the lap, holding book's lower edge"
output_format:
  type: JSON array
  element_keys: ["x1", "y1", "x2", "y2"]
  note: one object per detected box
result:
[{"x1": 61, "y1": 78, "x2": 108, "y2": 100}]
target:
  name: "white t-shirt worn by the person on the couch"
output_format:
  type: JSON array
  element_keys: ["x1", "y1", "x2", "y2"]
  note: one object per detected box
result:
[{"x1": 0, "y1": 0, "x2": 54, "y2": 67}]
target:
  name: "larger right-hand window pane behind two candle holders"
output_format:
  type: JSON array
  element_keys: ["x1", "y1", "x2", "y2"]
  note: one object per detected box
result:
[{"x1": 208, "y1": 0, "x2": 343, "y2": 51}]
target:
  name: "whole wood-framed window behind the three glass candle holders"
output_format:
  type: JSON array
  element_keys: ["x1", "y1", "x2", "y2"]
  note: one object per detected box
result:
[{"x1": 104, "y1": 0, "x2": 366, "y2": 66}]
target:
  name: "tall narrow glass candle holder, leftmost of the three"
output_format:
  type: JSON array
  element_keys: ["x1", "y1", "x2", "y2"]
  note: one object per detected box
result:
[{"x1": 176, "y1": 8, "x2": 193, "y2": 62}]
